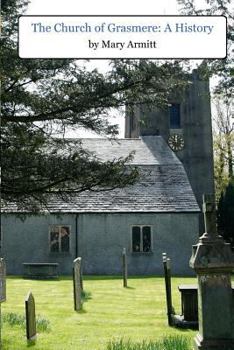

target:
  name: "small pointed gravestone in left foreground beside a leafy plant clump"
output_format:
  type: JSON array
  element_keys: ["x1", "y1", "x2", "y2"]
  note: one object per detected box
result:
[{"x1": 25, "y1": 292, "x2": 37, "y2": 340}]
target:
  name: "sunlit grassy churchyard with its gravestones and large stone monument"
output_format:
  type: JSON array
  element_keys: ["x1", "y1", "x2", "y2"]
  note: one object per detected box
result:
[{"x1": 0, "y1": 195, "x2": 234, "y2": 350}]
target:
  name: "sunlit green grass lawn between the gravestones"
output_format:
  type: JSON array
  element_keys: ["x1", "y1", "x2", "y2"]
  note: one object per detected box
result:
[{"x1": 2, "y1": 277, "x2": 196, "y2": 350}]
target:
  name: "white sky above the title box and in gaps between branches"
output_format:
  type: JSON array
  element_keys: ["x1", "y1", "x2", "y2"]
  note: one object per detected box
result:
[{"x1": 23, "y1": 0, "x2": 214, "y2": 137}]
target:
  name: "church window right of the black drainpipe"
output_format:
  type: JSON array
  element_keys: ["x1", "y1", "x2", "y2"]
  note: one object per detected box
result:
[{"x1": 132, "y1": 225, "x2": 152, "y2": 253}]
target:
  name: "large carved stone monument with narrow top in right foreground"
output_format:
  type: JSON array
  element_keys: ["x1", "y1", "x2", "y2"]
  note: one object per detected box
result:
[{"x1": 190, "y1": 195, "x2": 234, "y2": 350}]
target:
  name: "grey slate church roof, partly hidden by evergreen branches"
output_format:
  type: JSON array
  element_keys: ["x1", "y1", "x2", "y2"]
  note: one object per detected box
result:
[{"x1": 3, "y1": 136, "x2": 200, "y2": 213}]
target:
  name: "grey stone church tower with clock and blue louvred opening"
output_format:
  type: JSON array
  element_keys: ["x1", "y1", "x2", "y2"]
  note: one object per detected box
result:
[{"x1": 125, "y1": 70, "x2": 214, "y2": 208}]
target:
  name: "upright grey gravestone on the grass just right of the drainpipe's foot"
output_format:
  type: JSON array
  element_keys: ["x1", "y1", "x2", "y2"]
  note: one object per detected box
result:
[{"x1": 73, "y1": 257, "x2": 82, "y2": 311}]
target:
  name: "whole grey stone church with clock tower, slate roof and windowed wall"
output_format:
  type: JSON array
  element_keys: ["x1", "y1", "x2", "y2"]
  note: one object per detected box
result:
[{"x1": 1, "y1": 71, "x2": 214, "y2": 275}]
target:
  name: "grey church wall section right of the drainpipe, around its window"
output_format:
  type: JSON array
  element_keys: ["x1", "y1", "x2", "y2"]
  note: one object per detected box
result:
[{"x1": 79, "y1": 213, "x2": 198, "y2": 275}]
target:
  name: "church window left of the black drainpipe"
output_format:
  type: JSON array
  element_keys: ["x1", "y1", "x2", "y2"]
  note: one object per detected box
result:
[{"x1": 50, "y1": 225, "x2": 70, "y2": 253}]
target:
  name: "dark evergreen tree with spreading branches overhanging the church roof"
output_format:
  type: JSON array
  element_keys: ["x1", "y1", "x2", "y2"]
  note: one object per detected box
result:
[{"x1": 0, "y1": 0, "x2": 187, "y2": 210}]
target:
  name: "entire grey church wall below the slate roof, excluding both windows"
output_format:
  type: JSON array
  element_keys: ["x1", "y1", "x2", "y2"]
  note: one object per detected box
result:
[{"x1": 2, "y1": 213, "x2": 198, "y2": 275}]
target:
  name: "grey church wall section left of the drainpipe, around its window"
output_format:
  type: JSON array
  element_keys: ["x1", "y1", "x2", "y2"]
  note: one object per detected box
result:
[{"x1": 2, "y1": 214, "x2": 75, "y2": 275}]
